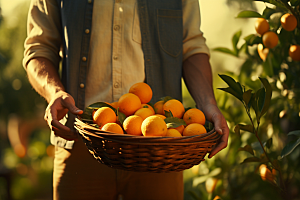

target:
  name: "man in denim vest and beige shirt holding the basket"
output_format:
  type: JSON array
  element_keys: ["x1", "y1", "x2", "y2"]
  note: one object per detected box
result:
[{"x1": 23, "y1": 0, "x2": 229, "y2": 200}]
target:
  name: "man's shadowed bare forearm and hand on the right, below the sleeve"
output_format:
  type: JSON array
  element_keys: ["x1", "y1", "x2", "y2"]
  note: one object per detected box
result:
[{"x1": 183, "y1": 53, "x2": 229, "y2": 158}]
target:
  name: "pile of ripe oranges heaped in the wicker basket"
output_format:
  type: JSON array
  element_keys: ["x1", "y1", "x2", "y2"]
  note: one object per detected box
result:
[{"x1": 92, "y1": 82, "x2": 207, "y2": 137}]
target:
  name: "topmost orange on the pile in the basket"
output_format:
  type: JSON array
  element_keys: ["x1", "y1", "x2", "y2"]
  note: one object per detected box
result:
[{"x1": 129, "y1": 83, "x2": 152, "y2": 103}]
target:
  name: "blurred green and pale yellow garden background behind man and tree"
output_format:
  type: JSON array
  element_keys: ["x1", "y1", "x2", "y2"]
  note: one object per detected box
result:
[{"x1": 0, "y1": 0, "x2": 300, "y2": 200}]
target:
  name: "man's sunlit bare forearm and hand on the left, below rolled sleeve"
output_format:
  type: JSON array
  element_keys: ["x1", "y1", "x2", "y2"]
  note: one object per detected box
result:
[{"x1": 26, "y1": 57, "x2": 83, "y2": 140}]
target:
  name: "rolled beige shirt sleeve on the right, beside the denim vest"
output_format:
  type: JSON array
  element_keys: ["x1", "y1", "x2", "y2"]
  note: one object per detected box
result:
[{"x1": 182, "y1": 0, "x2": 210, "y2": 60}]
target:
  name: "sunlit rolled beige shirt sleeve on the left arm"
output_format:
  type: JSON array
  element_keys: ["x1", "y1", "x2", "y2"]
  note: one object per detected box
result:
[{"x1": 23, "y1": 0, "x2": 62, "y2": 68}]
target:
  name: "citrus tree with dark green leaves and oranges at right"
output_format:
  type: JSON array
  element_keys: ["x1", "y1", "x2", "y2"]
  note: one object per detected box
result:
[{"x1": 210, "y1": 0, "x2": 300, "y2": 199}]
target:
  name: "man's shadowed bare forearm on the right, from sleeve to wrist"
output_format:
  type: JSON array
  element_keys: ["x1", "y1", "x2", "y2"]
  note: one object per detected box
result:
[{"x1": 183, "y1": 54, "x2": 216, "y2": 108}]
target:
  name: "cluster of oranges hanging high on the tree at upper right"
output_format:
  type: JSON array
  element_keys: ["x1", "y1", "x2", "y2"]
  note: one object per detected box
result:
[{"x1": 255, "y1": 13, "x2": 300, "y2": 61}]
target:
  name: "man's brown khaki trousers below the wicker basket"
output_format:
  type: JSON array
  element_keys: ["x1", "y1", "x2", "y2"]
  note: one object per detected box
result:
[{"x1": 53, "y1": 139, "x2": 183, "y2": 200}]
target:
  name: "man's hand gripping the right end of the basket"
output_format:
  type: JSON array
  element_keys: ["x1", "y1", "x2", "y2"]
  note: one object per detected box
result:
[{"x1": 203, "y1": 104, "x2": 229, "y2": 158}]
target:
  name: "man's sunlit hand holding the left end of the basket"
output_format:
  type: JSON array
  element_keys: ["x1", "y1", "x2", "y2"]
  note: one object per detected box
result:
[{"x1": 44, "y1": 91, "x2": 83, "y2": 140}]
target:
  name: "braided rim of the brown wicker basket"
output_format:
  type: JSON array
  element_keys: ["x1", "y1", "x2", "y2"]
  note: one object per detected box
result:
[{"x1": 74, "y1": 118, "x2": 221, "y2": 145}]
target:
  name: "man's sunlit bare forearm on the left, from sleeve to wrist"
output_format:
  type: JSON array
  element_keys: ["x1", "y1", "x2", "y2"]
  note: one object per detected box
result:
[{"x1": 26, "y1": 58, "x2": 64, "y2": 102}]
